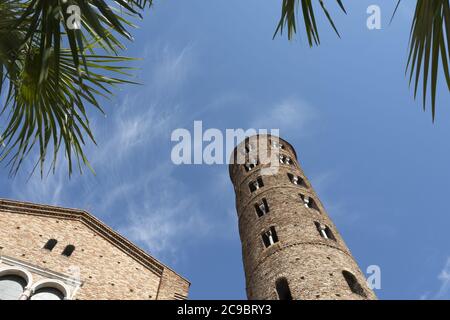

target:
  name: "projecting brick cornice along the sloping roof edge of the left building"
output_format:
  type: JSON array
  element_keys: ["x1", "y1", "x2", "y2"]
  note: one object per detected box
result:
[{"x1": 0, "y1": 198, "x2": 191, "y2": 286}]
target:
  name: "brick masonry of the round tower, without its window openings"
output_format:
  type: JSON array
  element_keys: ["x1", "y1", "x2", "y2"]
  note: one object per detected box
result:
[{"x1": 230, "y1": 136, "x2": 376, "y2": 299}]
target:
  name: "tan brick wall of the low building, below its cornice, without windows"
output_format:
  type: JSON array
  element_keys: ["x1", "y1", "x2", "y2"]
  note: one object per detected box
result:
[{"x1": 0, "y1": 205, "x2": 189, "y2": 300}]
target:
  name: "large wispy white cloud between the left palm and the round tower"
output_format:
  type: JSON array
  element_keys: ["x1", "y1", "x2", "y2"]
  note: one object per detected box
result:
[{"x1": 5, "y1": 45, "x2": 210, "y2": 261}]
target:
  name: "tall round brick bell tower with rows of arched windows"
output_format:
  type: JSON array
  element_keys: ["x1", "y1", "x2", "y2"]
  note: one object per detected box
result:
[{"x1": 229, "y1": 135, "x2": 376, "y2": 300}]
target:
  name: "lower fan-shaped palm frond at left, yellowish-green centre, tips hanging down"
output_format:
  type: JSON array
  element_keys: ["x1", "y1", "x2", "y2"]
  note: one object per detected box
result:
[{"x1": 0, "y1": 47, "x2": 137, "y2": 175}]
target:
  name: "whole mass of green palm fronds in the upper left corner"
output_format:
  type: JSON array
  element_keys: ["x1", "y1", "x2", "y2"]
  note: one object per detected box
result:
[{"x1": 0, "y1": 0, "x2": 152, "y2": 176}]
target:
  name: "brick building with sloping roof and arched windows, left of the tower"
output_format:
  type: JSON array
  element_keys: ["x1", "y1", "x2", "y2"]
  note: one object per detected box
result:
[{"x1": 0, "y1": 200, "x2": 190, "y2": 300}]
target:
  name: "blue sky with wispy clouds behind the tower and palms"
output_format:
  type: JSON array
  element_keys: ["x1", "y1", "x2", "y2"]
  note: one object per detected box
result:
[{"x1": 0, "y1": 0, "x2": 450, "y2": 299}]
